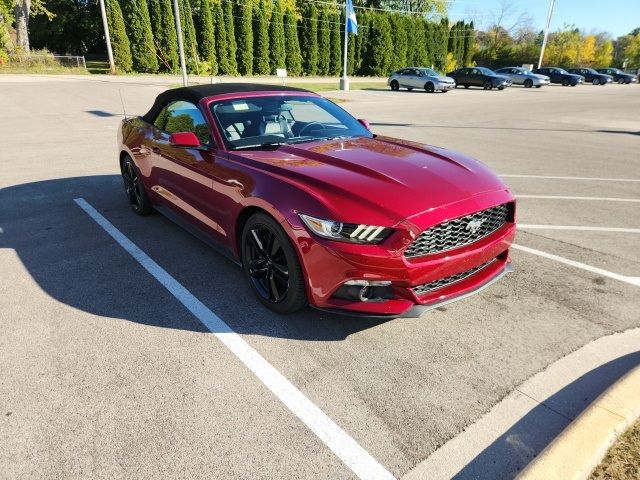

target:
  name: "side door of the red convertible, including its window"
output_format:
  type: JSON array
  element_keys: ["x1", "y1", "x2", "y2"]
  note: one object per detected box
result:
[{"x1": 152, "y1": 100, "x2": 226, "y2": 242}]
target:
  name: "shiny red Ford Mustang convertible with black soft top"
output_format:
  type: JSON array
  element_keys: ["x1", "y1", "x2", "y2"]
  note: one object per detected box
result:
[{"x1": 118, "y1": 83, "x2": 515, "y2": 317}]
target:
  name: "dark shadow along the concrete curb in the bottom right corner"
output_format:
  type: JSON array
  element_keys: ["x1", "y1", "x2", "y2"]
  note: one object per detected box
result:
[{"x1": 453, "y1": 352, "x2": 640, "y2": 480}]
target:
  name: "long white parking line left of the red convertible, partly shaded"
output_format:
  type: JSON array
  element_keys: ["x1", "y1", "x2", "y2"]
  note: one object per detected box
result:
[{"x1": 74, "y1": 198, "x2": 395, "y2": 480}]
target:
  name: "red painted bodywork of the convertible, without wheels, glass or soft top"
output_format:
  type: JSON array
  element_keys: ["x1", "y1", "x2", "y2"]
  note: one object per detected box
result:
[{"x1": 119, "y1": 91, "x2": 515, "y2": 315}]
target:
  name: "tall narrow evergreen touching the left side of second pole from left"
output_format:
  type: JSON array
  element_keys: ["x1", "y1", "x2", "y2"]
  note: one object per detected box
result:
[{"x1": 149, "y1": 0, "x2": 179, "y2": 72}]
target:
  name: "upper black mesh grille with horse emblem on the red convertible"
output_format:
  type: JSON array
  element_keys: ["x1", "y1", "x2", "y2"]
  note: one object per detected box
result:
[{"x1": 404, "y1": 203, "x2": 509, "y2": 258}]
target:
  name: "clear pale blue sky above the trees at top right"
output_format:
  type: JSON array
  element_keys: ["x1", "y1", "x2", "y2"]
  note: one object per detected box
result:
[{"x1": 449, "y1": 0, "x2": 640, "y2": 37}]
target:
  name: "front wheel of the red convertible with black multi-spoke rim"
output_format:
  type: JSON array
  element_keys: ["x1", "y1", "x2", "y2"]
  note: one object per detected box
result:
[{"x1": 241, "y1": 213, "x2": 307, "y2": 314}]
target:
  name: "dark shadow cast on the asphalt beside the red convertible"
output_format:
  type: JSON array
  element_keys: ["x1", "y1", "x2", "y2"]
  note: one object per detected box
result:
[{"x1": 0, "y1": 175, "x2": 387, "y2": 341}]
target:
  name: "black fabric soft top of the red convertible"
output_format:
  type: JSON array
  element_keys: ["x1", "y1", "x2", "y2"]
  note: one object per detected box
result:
[{"x1": 142, "y1": 83, "x2": 308, "y2": 123}]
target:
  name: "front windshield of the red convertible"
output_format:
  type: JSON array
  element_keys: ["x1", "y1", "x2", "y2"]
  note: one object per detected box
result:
[{"x1": 211, "y1": 95, "x2": 373, "y2": 150}]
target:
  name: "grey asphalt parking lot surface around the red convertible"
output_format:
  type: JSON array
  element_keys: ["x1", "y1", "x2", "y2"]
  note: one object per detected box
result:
[{"x1": 0, "y1": 76, "x2": 640, "y2": 479}]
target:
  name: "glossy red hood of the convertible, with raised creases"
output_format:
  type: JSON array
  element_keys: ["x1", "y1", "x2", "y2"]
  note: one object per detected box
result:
[{"x1": 231, "y1": 136, "x2": 508, "y2": 226}]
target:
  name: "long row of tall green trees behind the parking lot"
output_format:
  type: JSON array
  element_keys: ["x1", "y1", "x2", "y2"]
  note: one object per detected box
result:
[{"x1": 0, "y1": 0, "x2": 474, "y2": 76}]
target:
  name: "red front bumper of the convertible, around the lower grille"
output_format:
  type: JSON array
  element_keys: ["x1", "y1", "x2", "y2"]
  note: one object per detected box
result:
[{"x1": 285, "y1": 193, "x2": 516, "y2": 317}]
